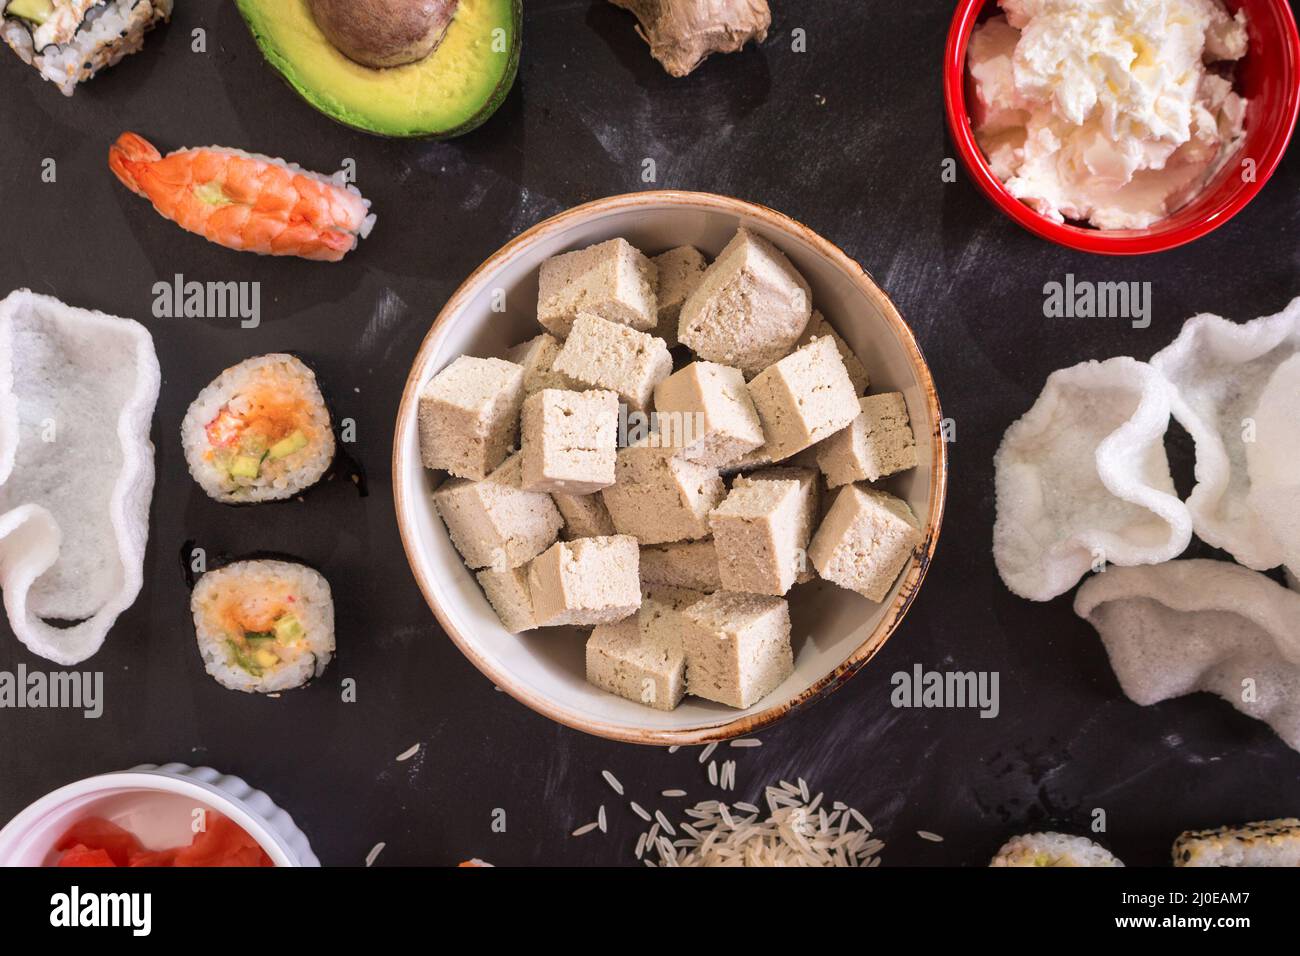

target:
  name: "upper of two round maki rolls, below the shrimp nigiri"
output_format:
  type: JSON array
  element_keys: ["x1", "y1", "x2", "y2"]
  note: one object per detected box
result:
[{"x1": 181, "y1": 354, "x2": 334, "y2": 505}]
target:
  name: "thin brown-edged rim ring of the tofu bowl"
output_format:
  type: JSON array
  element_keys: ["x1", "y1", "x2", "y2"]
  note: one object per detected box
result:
[{"x1": 393, "y1": 190, "x2": 948, "y2": 747}]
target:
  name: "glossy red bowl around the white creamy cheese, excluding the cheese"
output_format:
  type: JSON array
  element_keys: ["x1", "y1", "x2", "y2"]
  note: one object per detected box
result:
[{"x1": 944, "y1": 0, "x2": 1300, "y2": 255}]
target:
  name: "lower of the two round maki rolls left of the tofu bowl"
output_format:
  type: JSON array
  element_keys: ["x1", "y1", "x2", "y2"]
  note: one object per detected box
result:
[{"x1": 190, "y1": 561, "x2": 334, "y2": 693}]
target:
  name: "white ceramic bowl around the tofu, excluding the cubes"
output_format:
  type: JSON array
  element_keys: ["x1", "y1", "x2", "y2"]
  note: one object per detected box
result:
[{"x1": 393, "y1": 191, "x2": 946, "y2": 744}]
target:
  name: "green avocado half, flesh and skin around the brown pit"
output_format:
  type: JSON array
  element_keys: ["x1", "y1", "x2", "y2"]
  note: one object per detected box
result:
[{"x1": 237, "y1": 0, "x2": 524, "y2": 139}]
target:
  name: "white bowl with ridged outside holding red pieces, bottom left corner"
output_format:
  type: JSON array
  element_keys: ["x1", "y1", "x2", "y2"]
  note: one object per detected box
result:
[{"x1": 0, "y1": 763, "x2": 320, "y2": 866}]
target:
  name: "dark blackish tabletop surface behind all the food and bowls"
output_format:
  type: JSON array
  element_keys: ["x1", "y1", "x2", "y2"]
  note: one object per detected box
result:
[{"x1": 0, "y1": 0, "x2": 1300, "y2": 865}]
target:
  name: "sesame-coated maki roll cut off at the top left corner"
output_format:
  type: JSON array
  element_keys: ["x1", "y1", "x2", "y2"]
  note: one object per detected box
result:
[{"x1": 0, "y1": 0, "x2": 173, "y2": 96}]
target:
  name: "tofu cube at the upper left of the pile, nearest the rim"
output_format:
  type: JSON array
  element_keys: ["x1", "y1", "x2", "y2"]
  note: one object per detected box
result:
[{"x1": 537, "y1": 239, "x2": 659, "y2": 338}]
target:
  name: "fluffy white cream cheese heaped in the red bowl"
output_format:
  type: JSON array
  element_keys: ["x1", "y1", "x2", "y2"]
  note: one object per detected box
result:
[{"x1": 967, "y1": 0, "x2": 1248, "y2": 229}]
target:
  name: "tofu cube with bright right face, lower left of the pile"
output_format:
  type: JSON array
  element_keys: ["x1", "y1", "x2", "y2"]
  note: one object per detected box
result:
[{"x1": 528, "y1": 535, "x2": 641, "y2": 627}]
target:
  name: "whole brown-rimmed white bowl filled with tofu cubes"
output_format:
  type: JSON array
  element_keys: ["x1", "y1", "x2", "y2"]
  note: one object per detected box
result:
[{"x1": 393, "y1": 191, "x2": 946, "y2": 745}]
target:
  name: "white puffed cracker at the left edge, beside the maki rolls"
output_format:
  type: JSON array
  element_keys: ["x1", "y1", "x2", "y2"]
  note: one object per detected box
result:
[{"x1": 0, "y1": 290, "x2": 161, "y2": 666}]
